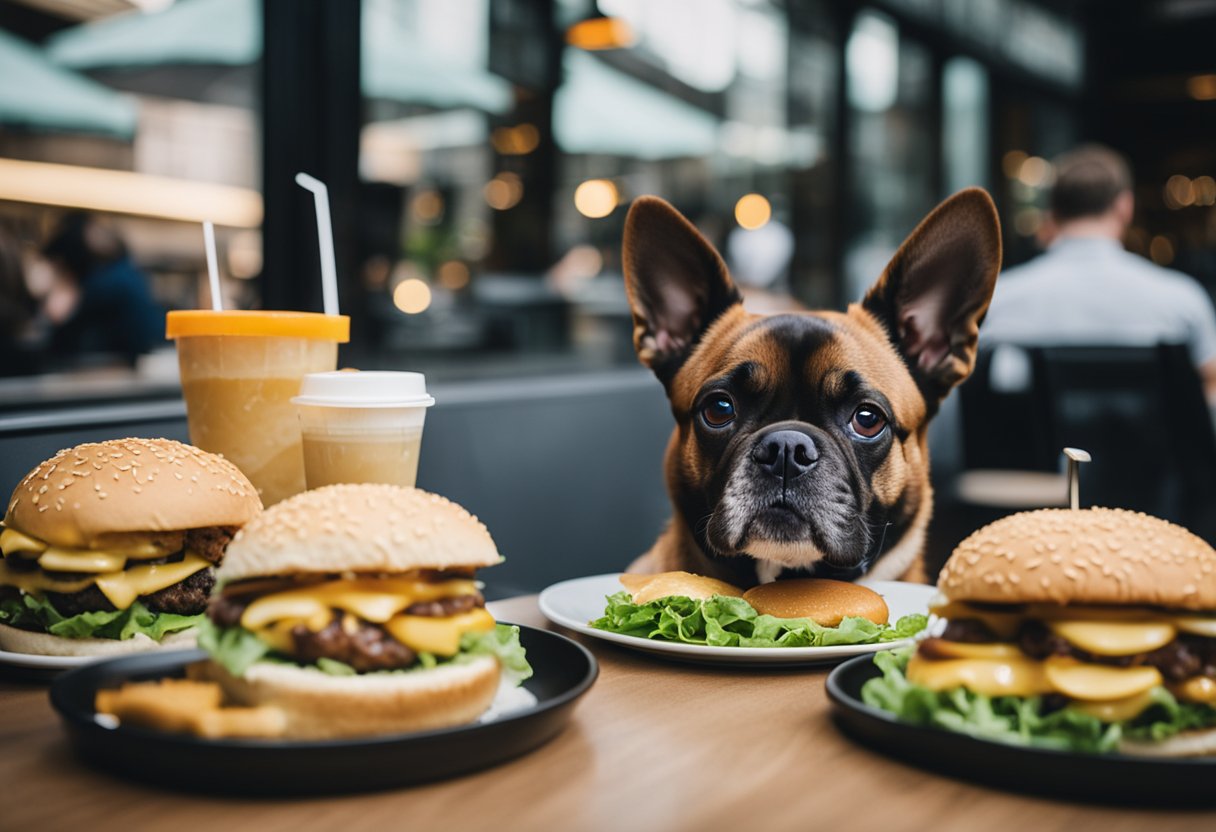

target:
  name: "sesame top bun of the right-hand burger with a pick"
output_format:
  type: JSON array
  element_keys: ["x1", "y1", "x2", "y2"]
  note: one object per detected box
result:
[{"x1": 938, "y1": 508, "x2": 1216, "y2": 611}]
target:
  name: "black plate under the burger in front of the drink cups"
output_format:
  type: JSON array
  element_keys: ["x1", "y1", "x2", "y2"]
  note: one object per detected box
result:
[{"x1": 51, "y1": 625, "x2": 599, "y2": 794}]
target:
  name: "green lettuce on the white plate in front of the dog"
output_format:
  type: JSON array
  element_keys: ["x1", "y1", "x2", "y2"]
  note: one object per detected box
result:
[{"x1": 591, "y1": 591, "x2": 929, "y2": 647}]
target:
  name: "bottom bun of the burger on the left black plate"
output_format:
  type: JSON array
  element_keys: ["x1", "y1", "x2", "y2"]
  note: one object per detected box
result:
[{"x1": 191, "y1": 656, "x2": 501, "y2": 740}]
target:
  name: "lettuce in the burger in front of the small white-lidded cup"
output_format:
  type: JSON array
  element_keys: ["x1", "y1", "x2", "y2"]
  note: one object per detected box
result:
[{"x1": 198, "y1": 619, "x2": 533, "y2": 685}]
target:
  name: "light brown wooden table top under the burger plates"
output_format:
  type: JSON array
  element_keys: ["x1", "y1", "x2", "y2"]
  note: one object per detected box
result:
[{"x1": 0, "y1": 597, "x2": 1216, "y2": 832}]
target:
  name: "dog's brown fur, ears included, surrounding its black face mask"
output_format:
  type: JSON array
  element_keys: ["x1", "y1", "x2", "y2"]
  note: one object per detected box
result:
[{"x1": 624, "y1": 189, "x2": 1001, "y2": 586}]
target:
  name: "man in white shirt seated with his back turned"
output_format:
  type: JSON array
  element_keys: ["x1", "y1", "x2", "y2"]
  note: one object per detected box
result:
[{"x1": 980, "y1": 145, "x2": 1216, "y2": 406}]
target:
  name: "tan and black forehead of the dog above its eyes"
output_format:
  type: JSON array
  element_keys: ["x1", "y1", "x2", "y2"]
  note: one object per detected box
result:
[{"x1": 672, "y1": 307, "x2": 925, "y2": 428}]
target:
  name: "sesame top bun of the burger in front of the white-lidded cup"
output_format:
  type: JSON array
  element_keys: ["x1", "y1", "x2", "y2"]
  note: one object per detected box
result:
[{"x1": 216, "y1": 484, "x2": 502, "y2": 584}]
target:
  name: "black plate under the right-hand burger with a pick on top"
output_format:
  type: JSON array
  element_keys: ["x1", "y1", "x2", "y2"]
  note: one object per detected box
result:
[{"x1": 827, "y1": 656, "x2": 1216, "y2": 806}]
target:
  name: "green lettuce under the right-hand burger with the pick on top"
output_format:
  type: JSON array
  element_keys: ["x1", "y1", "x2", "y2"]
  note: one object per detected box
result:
[{"x1": 861, "y1": 647, "x2": 1216, "y2": 753}]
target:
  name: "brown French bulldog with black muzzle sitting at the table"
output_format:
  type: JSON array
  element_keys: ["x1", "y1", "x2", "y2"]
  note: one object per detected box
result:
[{"x1": 623, "y1": 189, "x2": 1001, "y2": 588}]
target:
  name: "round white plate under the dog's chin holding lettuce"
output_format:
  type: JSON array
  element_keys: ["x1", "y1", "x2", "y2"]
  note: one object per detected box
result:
[{"x1": 540, "y1": 573, "x2": 938, "y2": 667}]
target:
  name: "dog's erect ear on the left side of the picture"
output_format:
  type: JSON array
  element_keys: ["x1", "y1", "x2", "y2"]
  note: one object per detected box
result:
[{"x1": 621, "y1": 197, "x2": 739, "y2": 386}]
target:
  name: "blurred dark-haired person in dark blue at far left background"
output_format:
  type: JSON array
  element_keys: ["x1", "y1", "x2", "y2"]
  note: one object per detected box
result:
[{"x1": 43, "y1": 212, "x2": 164, "y2": 365}]
